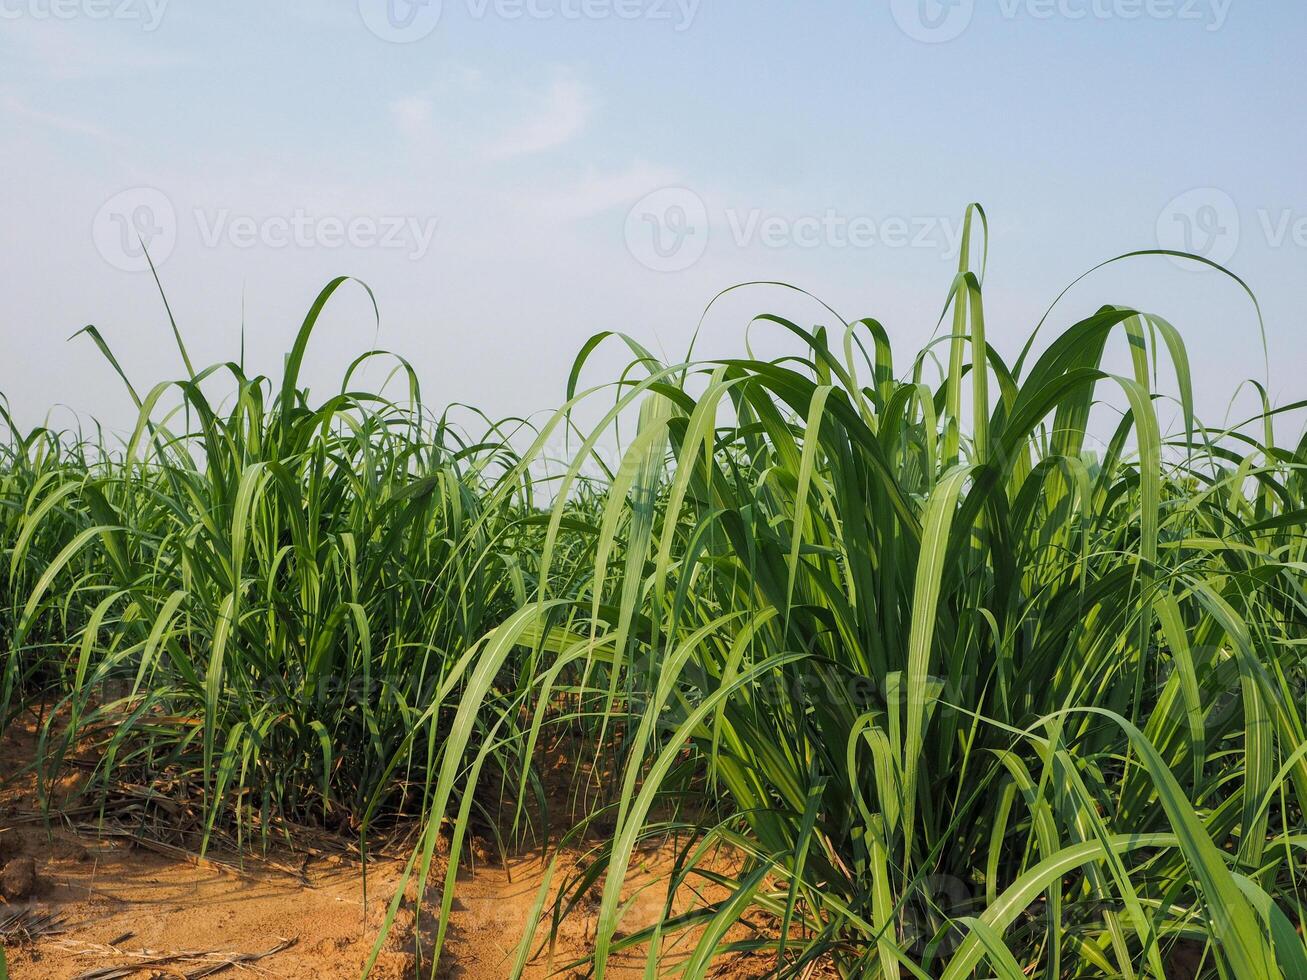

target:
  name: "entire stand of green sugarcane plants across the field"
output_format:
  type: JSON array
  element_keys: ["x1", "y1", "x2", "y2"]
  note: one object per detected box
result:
[{"x1": 0, "y1": 208, "x2": 1307, "y2": 980}]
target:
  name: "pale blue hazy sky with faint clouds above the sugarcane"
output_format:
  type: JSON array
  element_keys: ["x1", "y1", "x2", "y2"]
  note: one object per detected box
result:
[{"x1": 0, "y1": 0, "x2": 1307, "y2": 435}]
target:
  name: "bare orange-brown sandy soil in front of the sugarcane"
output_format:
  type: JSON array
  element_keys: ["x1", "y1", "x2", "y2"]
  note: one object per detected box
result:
[{"x1": 0, "y1": 716, "x2": 769, "y2": 980}]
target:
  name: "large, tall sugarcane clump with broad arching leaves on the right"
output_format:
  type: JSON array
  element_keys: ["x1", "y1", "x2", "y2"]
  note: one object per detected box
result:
[{"x1": 517, "y1": 209, "x2": 1307, "y2": 977}]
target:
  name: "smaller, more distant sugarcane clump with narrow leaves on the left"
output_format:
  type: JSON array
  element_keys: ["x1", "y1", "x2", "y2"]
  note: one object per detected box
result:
[{"x1": 0, "y1": 282, "x2": 546, "y2": 834}]
